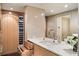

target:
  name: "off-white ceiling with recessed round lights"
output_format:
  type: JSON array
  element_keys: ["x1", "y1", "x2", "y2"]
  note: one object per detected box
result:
[{"x1": 2, "y1": 3, "x2": 78, "y2": 16}]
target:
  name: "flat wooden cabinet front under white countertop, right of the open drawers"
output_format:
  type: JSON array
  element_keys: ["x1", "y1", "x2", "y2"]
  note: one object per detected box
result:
[{"x1": 34, "y1": 44, "x2": 57, "y2": 56}]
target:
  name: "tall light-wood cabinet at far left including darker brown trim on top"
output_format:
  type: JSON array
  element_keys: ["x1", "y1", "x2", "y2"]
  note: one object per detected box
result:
[{"x1": 1, "y1": 10, "x2": 24, "y2": 55}]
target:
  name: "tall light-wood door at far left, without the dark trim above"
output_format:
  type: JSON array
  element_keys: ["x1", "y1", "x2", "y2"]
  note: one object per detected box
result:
[{"x1": 2, "y1": 14, "x2": 19, "y2": 54}]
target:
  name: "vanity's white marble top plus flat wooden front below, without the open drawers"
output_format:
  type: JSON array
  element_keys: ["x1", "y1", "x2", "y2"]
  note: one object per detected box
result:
[{"x1": 29, "y1": 38, "x2": 77, "y2": 56}]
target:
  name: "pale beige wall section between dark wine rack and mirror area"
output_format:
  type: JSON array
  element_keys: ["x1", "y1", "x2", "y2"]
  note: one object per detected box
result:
[{"x1": 25, "y1": 7, "x2": 46, "y2": 39}]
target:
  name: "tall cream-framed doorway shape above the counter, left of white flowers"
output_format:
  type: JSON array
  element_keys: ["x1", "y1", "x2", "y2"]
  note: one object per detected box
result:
[{"x1": 57, "y1": 15, "x2": 71, "y2": 40}]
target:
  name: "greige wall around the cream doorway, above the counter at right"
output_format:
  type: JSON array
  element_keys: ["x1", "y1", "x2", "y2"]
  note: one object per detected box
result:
[{"x1": 47, "y1": 9, "x2": 78, "y2": 37}]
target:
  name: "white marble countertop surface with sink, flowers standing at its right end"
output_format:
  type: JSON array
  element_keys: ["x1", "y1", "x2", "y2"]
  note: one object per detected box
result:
[{"x1": 29, "y1": 38, "x2": 77, "y2": 56}]
